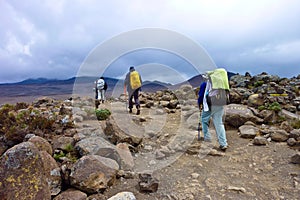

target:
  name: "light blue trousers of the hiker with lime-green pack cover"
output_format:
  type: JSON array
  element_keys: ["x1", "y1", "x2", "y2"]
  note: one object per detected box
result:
[{"x1": 201, "y1": 106, "x2": 227, "y2": 146}]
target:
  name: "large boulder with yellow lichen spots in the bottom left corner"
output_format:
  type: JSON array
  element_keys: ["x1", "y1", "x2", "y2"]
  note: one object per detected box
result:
[{"x1": 0, "y1": 142, "x2": 51, "y2": 200}]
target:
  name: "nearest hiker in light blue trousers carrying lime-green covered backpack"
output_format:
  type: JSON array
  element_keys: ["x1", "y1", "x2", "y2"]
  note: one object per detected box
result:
[{"x1": 198, "y1": 68, "x2": 229, "y2": 151}]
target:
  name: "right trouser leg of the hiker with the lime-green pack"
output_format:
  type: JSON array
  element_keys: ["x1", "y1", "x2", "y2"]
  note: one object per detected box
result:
[{"x1": 212, "y1": 106, "x2": 227, "y2": 148}]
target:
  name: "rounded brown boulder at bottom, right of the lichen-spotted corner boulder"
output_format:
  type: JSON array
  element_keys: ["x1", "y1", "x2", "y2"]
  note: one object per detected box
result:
[{"x1": 70, "y1": 155, "x2": 118, "y2": 194}]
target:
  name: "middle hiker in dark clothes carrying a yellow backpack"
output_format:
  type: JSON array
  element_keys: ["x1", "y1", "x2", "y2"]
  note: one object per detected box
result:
[{"x1": 124, "y1": 66, "x2": 142, "y2": 115}]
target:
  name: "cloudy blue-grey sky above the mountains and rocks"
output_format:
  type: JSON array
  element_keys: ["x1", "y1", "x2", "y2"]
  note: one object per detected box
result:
[{"x1": 0, "y1": 0, "x2": 300, "y2": 83}]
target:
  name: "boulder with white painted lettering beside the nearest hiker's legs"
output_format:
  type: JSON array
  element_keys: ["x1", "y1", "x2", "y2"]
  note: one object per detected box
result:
[{"x1": 225, "y1": 104, "x2": 263, "y2": 128}]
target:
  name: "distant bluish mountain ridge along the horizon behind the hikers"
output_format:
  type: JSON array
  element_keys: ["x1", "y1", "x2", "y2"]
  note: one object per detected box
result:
[{"x1": 0, "y1": 73, "x2": 234, "y2": 98}]
